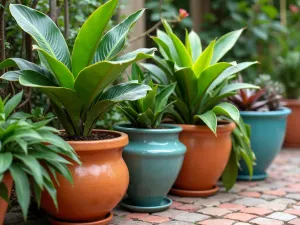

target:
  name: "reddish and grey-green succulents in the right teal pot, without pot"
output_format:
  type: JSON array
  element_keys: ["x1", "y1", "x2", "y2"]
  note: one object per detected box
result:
[{"x1": 229, "y1": 75, "x2": 282, "y2": 111}]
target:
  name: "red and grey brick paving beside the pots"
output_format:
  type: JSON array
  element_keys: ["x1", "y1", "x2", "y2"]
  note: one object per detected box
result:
[{"x1": 5, "y1": 150, "x2": 300, "y2": 225}]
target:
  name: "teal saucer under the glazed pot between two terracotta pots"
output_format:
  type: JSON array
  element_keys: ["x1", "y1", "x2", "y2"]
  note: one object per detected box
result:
[{"x1": 120, "y1": 197, "x2": 172, "y2": 213}]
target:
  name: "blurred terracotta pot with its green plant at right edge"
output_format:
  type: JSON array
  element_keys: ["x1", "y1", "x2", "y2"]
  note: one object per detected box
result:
[{"x1": 278, "y1": 51, "x2": 300, "y2": 148}]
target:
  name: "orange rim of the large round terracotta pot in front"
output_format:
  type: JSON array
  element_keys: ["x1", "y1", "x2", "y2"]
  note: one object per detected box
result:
[{"x1": 62, "y1": 129, "x2": 129, "y2": 151}]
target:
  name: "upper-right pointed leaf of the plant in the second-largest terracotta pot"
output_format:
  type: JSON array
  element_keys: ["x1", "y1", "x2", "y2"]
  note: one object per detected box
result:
[{"x1": 211, "y1": 28, "x2": 244, "y2": 64}]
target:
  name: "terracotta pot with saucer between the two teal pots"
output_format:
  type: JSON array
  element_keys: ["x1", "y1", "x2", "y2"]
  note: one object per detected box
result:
[{"x1": 171, "y1": 123, "x2": 235, "y2": 197}]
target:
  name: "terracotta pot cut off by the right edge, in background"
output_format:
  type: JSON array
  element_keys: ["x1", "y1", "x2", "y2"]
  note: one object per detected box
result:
[{"x1": 283, "y1": 99, "x2": 300, "y2": 148}]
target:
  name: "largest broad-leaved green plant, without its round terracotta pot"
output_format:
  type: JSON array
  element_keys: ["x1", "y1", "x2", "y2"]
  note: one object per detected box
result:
[{"x1": 0, "y1": 0, "x2": 155, "y2": 136}]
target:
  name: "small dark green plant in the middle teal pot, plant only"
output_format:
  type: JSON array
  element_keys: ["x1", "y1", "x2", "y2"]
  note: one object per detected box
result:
[{"x1": 119, "y1": 64, "x2": 176, "y2": 129}]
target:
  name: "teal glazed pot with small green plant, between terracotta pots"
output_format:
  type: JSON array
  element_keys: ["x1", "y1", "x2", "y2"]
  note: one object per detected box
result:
[{"x1": 114, "y1": 65, "x2": 186, "y2": 212}]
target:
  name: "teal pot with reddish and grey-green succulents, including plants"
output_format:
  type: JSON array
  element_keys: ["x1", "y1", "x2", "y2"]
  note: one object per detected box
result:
[{"x1": 229, "y1": 75, "x2": 291, "y2": 180}]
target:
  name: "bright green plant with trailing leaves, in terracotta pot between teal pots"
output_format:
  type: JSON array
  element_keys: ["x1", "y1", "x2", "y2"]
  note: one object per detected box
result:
[{"x1": 141, "y1": 21, "x2": 259, "y2": 189}]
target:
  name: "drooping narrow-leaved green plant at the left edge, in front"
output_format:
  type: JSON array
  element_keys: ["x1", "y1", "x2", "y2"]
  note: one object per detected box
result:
[{"x1": 0, "y1": 92, "x2": 80, "y2": 219}]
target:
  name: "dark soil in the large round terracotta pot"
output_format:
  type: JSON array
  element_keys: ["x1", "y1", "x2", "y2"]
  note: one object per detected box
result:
[{"x1": 60, "y1": 132, "x2": 119, "y2": 141}]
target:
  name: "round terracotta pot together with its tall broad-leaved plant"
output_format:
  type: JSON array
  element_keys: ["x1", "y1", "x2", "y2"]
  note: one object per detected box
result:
[{"x1": 0, "y1": 0, "x2": 155, "y2": 224}]
